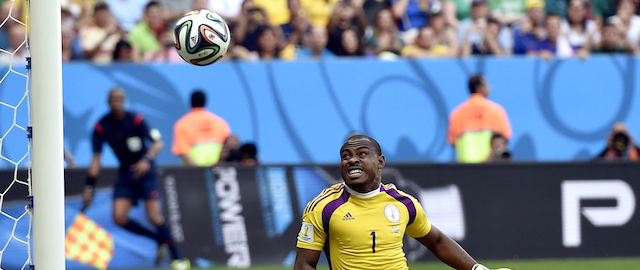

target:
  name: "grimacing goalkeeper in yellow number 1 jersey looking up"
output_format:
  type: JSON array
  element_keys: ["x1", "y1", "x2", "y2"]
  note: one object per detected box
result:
[{"x1": 293, "y1": 135, "x2": 510, "y2": 270}]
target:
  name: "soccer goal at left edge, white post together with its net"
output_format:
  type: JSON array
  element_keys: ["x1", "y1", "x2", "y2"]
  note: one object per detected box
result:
[{"x1": 0, "y1": 0, "x2": 64, "y2": 270}]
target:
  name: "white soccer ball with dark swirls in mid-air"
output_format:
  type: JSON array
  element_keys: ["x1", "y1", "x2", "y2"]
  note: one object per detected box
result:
[{"x1": 174, "y1": 9, "x2": 231, "y2": 66}]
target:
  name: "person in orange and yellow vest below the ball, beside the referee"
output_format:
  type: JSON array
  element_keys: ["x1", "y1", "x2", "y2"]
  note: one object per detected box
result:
[{"x1": 171, "y1": 90, "x2": 231, "y2": 167}]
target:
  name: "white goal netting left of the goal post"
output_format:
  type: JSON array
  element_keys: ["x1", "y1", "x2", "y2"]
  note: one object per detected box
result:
[{"x1": 0, "y1": 1, "x2": 32, "y2": 269}]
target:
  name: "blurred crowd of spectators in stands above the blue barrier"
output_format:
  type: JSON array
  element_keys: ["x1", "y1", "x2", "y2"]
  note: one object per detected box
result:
[{"x1": 0, "y1": 0, "x2": 640, "y2": 64}]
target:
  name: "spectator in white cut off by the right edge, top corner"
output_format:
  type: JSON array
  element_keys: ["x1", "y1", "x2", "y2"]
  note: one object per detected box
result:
[{"x1": 607, "y1": 0, "x2": 640, "y2": 49}]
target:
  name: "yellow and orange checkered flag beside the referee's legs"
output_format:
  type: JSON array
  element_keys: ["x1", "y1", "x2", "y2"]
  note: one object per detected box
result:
[{"x1": 64, "y1": 213, "x2": 113, "y2": 269}]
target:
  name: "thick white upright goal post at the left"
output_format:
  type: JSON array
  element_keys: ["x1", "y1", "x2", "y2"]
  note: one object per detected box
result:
[{"x1": 28, "y1": 0, "x2": 65, "y2": 270}]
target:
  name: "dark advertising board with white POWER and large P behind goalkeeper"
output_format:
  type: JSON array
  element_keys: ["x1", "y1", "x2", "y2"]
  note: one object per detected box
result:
[{"x1": 0, "y1": 162, "x2": 640, "y2": 268}]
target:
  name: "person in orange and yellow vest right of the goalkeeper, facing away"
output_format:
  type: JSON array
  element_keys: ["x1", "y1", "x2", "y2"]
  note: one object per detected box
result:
[{"x1": 447, "y1": 75, "x2": 511, "y2": 163}]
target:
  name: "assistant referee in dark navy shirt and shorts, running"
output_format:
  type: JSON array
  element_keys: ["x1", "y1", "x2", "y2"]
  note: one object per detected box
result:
[{"x1": 82, "y1": 88, "x2": 190, "y2": 269}]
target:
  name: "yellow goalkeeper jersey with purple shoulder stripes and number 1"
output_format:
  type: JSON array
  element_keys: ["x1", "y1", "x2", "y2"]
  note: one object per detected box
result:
[{"x1": 297, "y1": 183, "x2": 431, "y2": 270}]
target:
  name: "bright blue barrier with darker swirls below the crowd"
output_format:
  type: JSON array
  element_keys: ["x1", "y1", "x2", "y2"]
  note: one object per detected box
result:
[{"x1": 0, "y1": 55, "x2": 640, "y2": 168}]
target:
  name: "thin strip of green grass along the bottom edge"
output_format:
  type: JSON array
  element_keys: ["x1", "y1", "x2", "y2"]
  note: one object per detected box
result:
[{"x1": 132, "y1": 257, "x2": 640, "y2": 270}]
